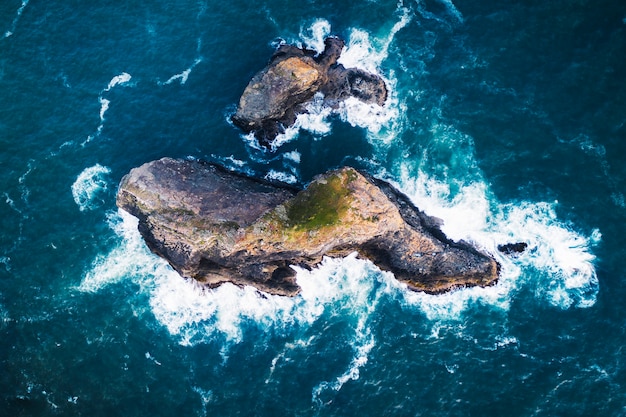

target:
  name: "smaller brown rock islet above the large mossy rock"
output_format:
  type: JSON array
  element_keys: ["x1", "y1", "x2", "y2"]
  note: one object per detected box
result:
[{"x1": 232, "y1": 37, "x2": 387, "y2": 146}]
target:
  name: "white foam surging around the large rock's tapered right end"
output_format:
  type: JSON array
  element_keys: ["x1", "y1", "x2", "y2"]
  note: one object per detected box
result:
[{"x1": 398, "y1": 162, "x2": 601, "y2": 312}]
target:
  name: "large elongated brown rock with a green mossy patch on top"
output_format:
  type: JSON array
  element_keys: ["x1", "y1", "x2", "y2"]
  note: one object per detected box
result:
[{"x1": 117, "y1": 158, "x2": 499, "y2": 295}]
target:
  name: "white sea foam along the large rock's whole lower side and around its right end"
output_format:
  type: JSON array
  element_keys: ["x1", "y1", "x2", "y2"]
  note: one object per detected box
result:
[{"x1": 79, "y1": 161, "x2": 601, "y2": 404}]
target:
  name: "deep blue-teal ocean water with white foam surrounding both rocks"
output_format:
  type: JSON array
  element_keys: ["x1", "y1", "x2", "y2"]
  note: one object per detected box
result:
[{"x1": 0, "y1": 0, "x2": 626, "y2": 417}]
